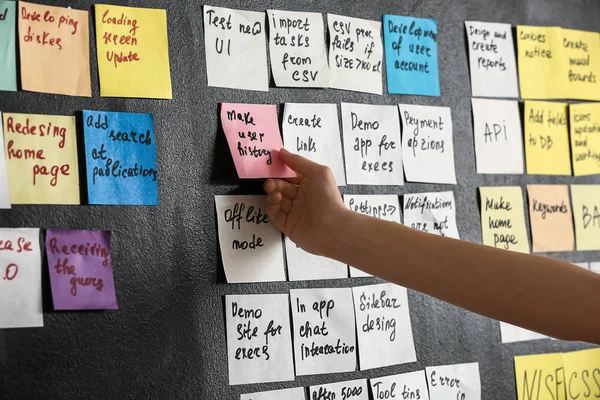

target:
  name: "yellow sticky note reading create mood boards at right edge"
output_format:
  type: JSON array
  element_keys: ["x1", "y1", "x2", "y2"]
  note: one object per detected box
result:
[{"x1": 562, "y1": 29, "x2": 600, "y2": 100}]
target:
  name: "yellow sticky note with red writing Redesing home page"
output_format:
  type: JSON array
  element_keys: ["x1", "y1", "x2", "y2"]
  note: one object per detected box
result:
[{"x1": 3, "y1": 113, "x2": 79, "y2": 204}]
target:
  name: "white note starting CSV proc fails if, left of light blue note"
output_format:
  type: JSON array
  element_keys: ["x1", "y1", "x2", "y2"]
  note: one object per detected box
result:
[{"x1": 327, "y1": 14, "x2": 383, "y2": 94}]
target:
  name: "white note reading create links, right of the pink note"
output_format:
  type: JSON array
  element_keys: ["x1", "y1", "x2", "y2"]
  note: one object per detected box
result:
[{"x1": 281, "y1": 103, "x2": 346, "y2": 186}]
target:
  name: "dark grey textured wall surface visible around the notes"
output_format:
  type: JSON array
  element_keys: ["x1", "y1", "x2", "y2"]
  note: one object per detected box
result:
[{"x1": 0, "y1": 0, "x2": 600, "y2": 400}]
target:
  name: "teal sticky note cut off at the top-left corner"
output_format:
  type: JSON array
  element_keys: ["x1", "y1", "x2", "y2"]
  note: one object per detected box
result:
[{"x1": 0, "y1": 0, "x2": 17, "y2": 91}]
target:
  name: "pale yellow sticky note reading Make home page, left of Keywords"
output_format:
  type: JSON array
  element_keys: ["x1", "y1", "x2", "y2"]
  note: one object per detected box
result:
[{"x1": 479, "y1": 186, "x2": 529, "y2": 253}]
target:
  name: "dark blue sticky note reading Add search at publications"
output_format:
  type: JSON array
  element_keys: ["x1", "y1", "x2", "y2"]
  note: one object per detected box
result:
[{"x1": 83, "y1": 110, "x2": 158, "y2": 205}]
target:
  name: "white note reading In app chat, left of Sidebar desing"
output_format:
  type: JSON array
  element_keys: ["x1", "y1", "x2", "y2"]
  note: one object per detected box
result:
[{"x1": 290, "y1": 288, "x2": 356, "y2": 376}]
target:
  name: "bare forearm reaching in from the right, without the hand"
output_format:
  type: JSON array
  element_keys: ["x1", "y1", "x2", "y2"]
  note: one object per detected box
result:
[{"x1": 325, "y1": 211, "x2": 600, "y2": 344}]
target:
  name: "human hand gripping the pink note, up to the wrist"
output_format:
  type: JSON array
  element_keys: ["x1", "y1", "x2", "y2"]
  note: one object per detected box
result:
[{"x1": 264, "y1": 149, "x2": 348, "y2": 255}]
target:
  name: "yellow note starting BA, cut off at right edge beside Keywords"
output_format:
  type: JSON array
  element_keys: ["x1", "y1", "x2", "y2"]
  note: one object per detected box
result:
[{"x1": 571, "y1": 185, "x2": 600, "y2": 251}]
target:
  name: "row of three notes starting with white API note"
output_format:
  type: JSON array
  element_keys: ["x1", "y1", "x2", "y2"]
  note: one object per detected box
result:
[{"x1": 471, "y1": 98, "x2": 600, "y2": 176}]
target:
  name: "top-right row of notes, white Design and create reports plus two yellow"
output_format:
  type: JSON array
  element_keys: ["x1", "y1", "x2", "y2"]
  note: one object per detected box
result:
[{"x1": 465, "y1": 21, "x2": 600, "y2": 100}]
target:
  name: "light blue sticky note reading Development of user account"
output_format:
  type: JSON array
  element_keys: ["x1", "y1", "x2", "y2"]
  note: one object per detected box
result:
[{"x1": 383, "y1": 14, "x2": 440, "y2": 96}]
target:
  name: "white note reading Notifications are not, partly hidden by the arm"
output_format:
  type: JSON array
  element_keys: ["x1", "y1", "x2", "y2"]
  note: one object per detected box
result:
[{"x1": 404, "y1": 192, "x2": 460, "y2": 239}]
